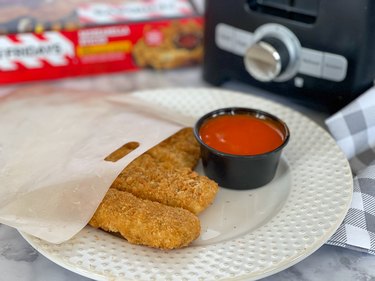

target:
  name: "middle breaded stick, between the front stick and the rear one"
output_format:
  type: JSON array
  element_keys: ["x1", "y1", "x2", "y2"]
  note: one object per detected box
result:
[{"x1": 111, "y1": 154, "x2": 218, "y2": 214}]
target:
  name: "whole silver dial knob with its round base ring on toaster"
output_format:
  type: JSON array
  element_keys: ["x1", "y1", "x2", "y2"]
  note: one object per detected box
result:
[{"x1": 244, "y1": 24, "x2": 301, "y2": 82}]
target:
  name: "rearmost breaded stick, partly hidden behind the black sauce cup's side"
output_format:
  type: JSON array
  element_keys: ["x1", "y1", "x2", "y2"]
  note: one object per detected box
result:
[{"x1": 146, "y1": 128, "x2": 200, "y2": 169}]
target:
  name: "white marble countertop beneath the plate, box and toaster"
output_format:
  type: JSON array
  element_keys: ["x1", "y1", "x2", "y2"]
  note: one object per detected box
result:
[{"x1": 0, "y1": 67, "x2": 375, "y2": 281}]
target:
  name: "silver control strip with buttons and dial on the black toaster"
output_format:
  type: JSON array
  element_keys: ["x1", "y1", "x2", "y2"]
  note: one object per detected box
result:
[{"x1": 215, "y1": 23, "x2": 348, "y2": 82}]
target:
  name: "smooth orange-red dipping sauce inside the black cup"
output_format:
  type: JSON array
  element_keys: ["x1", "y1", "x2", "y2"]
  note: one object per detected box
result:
[{"x1": 199, "y1": 114, "x2": 285, "y2": 155}]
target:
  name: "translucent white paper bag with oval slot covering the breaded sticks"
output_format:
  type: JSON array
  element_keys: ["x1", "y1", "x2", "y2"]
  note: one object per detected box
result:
[{"x1": 0, "y1": 87, "x2": 181, "y2": 243}]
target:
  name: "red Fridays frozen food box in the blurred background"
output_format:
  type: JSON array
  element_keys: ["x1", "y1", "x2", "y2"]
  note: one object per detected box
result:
[{"x1": 0, "y1": 0, "x2": 203, "y2": 84}]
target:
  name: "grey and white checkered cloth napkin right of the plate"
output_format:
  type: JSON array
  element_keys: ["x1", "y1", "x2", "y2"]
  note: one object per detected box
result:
[{"x1": 326, "y1": 87, "x2": 375, "y2": 255}]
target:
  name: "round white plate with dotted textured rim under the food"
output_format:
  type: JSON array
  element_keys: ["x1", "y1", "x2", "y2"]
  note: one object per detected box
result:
[{"x1": 22, "y1": 89, "x2": 352, "y2": 281}]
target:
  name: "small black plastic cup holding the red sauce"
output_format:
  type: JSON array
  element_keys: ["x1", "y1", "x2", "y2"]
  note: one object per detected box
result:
[{"x1": 194, "y1": 107, "x2": 290, "y2": 190}]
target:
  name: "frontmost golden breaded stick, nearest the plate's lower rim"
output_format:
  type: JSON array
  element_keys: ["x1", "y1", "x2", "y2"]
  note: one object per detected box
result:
[{"x1": 89, "y1": 189, "x2": 200, "y2": 249}]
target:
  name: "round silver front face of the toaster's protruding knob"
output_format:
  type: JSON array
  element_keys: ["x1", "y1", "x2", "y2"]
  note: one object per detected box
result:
[{"x1": 244, "y1": 41, "x2": 282, "y2": 82}]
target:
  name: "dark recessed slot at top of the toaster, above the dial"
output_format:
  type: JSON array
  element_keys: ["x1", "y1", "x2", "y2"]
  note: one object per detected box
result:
[{"x1": 247, "y1": 0, "x2": 319, "y2": 24}]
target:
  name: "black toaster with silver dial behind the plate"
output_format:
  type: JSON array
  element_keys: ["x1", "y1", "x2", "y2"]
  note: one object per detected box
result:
[{"x1": 203, "y1": 0, "x2": 375, "y2": 112}]
